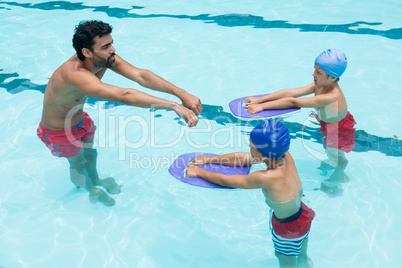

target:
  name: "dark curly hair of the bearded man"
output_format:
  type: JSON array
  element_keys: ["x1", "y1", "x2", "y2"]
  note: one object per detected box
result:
[{"x1": 73, "y1": 20, "x2": 112, "y2": 61}]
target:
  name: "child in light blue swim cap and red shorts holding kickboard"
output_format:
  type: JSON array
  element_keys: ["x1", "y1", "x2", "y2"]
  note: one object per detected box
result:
[{"x1": 245, "y1": 49, "x2": 356, "y2": 170}]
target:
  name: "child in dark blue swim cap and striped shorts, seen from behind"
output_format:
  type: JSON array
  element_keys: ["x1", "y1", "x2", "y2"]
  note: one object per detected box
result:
[{"x1": 186, "y1": 120, "x2": 315, "y2": 267}]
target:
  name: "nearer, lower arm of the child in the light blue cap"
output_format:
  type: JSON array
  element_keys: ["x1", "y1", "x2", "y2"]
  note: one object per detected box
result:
[{"x1": 247, "y1": 89, "x2": 337, "y2": 114}]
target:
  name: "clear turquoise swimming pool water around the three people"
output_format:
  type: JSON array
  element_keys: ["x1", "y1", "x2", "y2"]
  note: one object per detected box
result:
[{"x1": 0, "y1": 0, "x2": 402, "y2": 267}]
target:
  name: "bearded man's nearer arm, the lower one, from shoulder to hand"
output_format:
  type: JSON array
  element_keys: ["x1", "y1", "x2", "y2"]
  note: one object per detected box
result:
[{"x1": 68, "y1": 70, "x2": 198, "y2": 127}]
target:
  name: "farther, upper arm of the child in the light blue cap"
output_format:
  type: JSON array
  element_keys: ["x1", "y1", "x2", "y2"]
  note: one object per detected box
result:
[{"x1": 244, "y1": 83, "x2": 315, "y2": 106}]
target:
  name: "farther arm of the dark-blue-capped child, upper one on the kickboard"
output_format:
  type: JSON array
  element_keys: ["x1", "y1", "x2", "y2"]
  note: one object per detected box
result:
[{"x1": 190, "y1": 152, "x2": 256, "y2": 167}]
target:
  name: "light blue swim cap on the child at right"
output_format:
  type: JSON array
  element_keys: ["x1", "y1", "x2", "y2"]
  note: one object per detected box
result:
[{"x1": 315, "y1": 49, "x2": 348, "y2": 78}]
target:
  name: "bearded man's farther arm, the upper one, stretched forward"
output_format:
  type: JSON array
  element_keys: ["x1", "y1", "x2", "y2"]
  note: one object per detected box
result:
[{"x1": 111, "y1": 55, "x2": 202, "y2": 115}]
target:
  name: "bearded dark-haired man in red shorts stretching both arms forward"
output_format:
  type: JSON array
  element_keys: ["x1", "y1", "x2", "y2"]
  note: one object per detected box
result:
[{"x1": 37, "y1": 21, "x2": 202, "y2": 206}]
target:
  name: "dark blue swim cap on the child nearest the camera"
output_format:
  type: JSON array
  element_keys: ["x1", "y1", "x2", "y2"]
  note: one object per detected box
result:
[{"x1": 250, "y1": 120, "x2": 290, "y2": 159}]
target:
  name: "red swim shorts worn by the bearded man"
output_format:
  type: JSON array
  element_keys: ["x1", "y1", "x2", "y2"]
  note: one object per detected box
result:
[{"x1": 37, "y1": 112, "x2": 96, "y2": 158}]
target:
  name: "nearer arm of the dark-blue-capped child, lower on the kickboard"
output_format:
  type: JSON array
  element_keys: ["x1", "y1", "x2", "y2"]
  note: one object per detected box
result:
[{"x1": 186, "y1": 165, "x2": 269, "y2": 189}]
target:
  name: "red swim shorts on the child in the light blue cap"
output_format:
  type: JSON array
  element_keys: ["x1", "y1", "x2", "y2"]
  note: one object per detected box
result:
[{"x1": 316, "y1": 112, "x2": 356, "y2": 153}]
